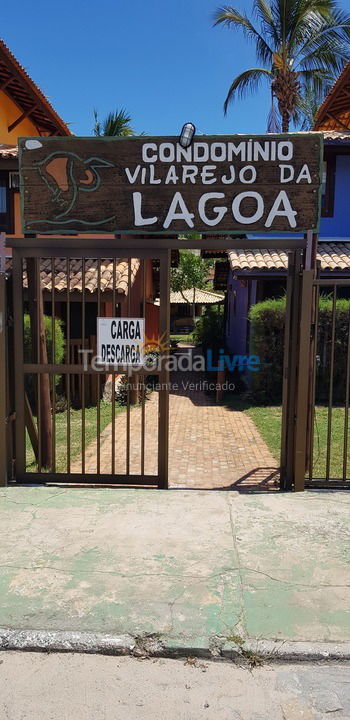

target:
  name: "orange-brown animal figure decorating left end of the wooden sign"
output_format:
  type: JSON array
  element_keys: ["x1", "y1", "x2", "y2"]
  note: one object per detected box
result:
[{"x1": 23, "y1": 140, "x2": 115, "y2": 225}]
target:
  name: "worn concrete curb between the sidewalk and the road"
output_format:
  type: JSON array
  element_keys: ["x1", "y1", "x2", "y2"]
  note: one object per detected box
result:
[{"x1": 0, "y1": 629, "x2": 350, "y2": 665}]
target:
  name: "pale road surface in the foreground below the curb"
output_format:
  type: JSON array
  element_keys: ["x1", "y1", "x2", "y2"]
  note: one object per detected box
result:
[{"x1": 0, "y1": 651, "x2": 350, "y2": 720}]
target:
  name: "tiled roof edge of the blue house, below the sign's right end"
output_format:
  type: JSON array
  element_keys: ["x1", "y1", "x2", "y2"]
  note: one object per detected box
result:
[{"x1": 227, "y1": 242, "x2": 350, "y2": 273}]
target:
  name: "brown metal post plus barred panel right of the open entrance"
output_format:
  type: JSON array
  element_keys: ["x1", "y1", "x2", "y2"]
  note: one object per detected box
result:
[{"x1": 281, "y1": 252, "x2": 350, "y2": 491}]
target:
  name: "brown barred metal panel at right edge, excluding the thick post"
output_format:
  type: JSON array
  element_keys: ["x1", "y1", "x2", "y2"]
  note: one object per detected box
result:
[{"x1": 306, "y1": 272, "x2": 350, "y2": 488}]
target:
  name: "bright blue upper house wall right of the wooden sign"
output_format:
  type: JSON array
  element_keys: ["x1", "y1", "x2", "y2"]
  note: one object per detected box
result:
[{"x1": 319, "y1": 154, "x2": 350, "y2": 239}]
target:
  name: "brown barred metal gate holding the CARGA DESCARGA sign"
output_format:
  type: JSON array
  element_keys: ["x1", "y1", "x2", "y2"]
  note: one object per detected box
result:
[{"x1": 8, "y1": 238, "x2": 170, "y2": 488}]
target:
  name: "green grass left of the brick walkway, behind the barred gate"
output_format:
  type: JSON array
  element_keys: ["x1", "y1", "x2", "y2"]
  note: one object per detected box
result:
[{"x1": 26, "y1": 402, "x2": 125, "y2": 472}]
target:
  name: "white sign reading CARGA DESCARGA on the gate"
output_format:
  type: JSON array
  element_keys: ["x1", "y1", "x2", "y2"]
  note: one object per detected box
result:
[{"x1": 97, "y1": 317, "x2": 145, "y2": 366}]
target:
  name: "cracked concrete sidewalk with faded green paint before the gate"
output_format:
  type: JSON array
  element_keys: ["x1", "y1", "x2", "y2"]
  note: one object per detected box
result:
[{"x1": 0, "y1": 487, "x2": 350, "y2": 656}]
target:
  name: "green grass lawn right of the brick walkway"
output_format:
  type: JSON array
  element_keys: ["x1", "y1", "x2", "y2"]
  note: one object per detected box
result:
[{"x1": 224, "y1": 400, "x2": 350, "y2": 478}]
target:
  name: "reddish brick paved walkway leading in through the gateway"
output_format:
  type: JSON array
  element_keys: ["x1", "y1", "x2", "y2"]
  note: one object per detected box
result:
[{"x1": 72, "y1": 358, "x2": 278, "y2": 489}]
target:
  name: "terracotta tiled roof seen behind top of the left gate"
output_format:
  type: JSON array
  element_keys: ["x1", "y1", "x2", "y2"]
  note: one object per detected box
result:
[{"x1": 7, "y1": 258, "x2": 140, "y2": 295}]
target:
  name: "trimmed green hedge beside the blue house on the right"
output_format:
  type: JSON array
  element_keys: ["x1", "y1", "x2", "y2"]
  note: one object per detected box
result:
[{"x1": 249, "y1": 296, "x2": 350, "y2": 404}]
